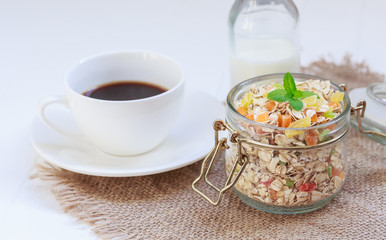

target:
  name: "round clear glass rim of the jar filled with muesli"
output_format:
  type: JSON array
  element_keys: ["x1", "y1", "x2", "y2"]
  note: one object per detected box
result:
[{"x1": 226, "y1": 73, "x2": 351, "y2": 131}]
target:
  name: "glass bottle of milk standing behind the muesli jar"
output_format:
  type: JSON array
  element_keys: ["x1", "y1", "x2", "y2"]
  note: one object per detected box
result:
[{"x1": 229, "y1": 0, "x2": 300, "y2": 86}]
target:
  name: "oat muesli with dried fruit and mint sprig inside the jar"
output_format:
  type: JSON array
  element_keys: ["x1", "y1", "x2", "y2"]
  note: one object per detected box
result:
[{"x1": 225, "y1": 73, "x2": 350, "y2": 211}]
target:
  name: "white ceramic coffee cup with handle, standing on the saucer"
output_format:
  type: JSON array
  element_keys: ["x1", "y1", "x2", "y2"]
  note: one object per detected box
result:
[{"x1": 39, "y1": 51, "x2": 185, "y2": 156}]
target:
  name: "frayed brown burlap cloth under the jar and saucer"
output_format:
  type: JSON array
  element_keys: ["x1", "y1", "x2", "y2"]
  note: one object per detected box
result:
[{"x1": 34, "y1": 57, "x2": 386, "y2": 239}]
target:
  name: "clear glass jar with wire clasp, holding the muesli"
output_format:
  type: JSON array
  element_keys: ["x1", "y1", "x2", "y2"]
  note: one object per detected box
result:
[{"x1": 192, "y1": 74, "x2": 352, "y2": 214}]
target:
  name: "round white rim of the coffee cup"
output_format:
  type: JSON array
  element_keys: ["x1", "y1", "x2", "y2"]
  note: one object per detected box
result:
[{"x1": 65, "y1": 49, "x2": 185, "y2": 104}]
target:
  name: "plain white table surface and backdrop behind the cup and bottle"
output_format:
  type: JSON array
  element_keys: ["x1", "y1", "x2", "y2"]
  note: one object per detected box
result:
[{"x1": 0, "y1": 0, "x2": 386, "y2": 239}]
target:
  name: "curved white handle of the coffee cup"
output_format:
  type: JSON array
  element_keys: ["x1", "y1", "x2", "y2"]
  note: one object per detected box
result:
[{"x1": 39, "y1": 96, "x2": 84, "y2": 139}]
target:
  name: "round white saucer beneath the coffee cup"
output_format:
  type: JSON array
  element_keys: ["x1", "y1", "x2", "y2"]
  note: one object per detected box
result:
[{"x1": 31, "y1": 89, "x2": 225, "y2": 177}]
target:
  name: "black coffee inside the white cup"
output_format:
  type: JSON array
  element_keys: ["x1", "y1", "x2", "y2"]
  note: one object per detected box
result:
[{"x1": 83, "y1": 81, "x2": 166, "y2": 101}]
